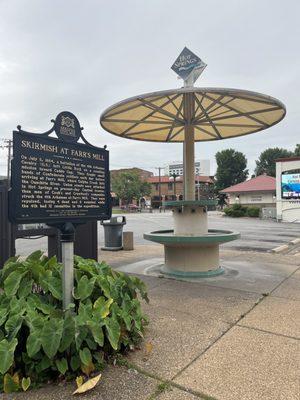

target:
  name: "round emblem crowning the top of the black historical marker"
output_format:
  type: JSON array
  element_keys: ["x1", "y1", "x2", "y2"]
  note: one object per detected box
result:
[{"x1": 54, "y1": 111, "x2": 81, "y2": 143}]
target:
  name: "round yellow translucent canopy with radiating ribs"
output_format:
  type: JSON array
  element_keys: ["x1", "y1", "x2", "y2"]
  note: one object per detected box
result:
[{"x1": 100, "y1": 87, "x2": 286, "y2": 142}]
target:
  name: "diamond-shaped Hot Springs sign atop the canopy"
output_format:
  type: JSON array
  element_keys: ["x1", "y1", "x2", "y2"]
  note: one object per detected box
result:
[{"x1": 171, "y1": 47, "x2": 206, "y2": 81}]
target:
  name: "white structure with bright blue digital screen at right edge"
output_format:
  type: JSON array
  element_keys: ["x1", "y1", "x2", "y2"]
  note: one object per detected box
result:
[{"x1": 276, "y1": 157, "x2": 300, "y2": 222}]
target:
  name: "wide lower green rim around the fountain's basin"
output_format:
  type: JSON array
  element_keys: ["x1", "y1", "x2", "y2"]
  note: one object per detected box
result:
[{"x1": 144, "y1": 229, "x2": 241, "y2": 245}]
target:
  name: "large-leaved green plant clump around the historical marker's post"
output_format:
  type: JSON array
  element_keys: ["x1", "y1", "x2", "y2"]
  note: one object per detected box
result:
[{"x1": 0, "y1": 251, "x2": 148, "y2": 393}]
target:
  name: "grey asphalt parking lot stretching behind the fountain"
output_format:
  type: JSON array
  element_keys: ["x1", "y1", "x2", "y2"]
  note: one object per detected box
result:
[{"x1": 17, "y1": 212, "x2": 300, "y2": 255}]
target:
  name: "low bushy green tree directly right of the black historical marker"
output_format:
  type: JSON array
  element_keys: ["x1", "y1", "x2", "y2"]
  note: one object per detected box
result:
[{"x1": 111, "y1": 172, "x2": 151, "y2": 205}]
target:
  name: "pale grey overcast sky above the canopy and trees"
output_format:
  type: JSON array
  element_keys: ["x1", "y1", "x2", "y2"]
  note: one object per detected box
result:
[{"x1": 0, "y1": 0, "x2": 300, "y2": 174}]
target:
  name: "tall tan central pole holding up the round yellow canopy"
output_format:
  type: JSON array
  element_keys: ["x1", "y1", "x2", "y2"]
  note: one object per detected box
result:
[{"x1": 183, "y1": 82, "x2": 195, "y2": 200}]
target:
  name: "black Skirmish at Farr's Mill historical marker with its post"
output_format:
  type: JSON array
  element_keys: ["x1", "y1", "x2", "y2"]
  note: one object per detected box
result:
[{"x1": 9, "y1": 111, "x2": 111, "y2": 309}]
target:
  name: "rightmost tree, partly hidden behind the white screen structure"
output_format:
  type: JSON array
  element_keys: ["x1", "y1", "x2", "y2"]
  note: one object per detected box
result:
[{"x1": 255, "y1": 147, "x2": 294, "y2": 177}]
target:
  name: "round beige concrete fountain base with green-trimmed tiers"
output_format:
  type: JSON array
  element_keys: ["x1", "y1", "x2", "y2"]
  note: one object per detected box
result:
[{"x1": 144, "y1": 200, "x2": 240, "y2": 277}]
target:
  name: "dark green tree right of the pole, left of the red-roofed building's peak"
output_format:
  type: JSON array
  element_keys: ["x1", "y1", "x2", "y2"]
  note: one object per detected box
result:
[{"x1": 215, "y1": 149, "x2": 248, "y2": 191}]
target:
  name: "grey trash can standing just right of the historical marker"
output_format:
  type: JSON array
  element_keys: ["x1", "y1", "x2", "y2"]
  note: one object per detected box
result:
[{"x1": 101, "y1": 216, "x2": 126, "y2": 251}]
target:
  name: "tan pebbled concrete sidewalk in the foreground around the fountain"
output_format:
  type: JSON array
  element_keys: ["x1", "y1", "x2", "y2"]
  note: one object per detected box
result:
[{"x1": 2, "y1": 245, "x2": 300, "y2": 400}]
